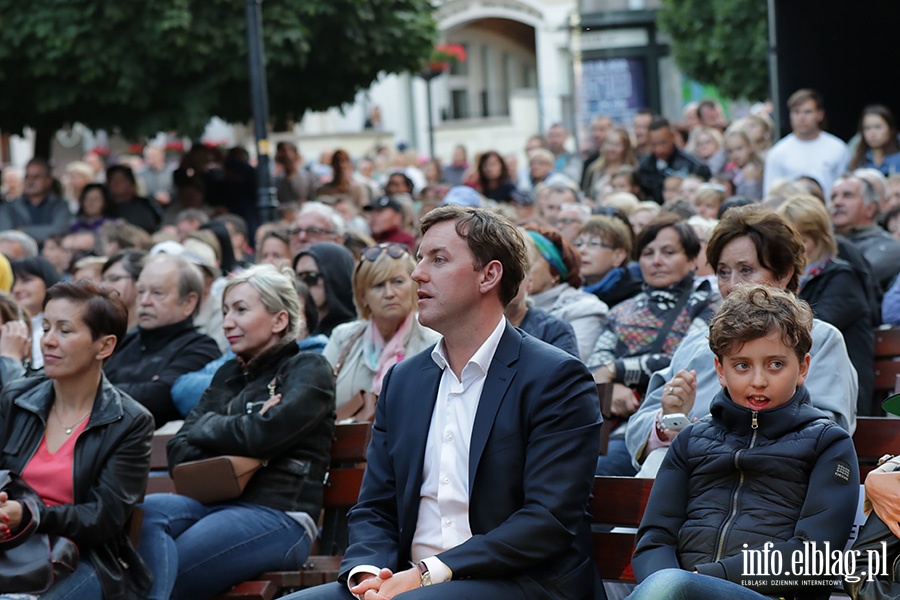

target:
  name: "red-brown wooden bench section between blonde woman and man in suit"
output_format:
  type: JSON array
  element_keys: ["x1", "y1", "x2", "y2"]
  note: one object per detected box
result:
[{"x1": 214, "y1": 423, "x2": 372, "y2": 600}]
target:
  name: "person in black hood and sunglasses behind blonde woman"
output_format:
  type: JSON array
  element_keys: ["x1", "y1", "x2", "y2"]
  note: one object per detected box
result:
[{"x1": 294, "y1": 242, "x2": 356, "y2": 336}]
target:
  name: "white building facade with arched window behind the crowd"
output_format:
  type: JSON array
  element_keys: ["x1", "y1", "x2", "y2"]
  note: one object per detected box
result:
[{"x1": 288, "y1": 0, "x2": 578, "y2": 160}]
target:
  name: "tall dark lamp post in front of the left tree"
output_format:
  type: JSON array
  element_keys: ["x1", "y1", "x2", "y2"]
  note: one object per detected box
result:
[{"x1": 246, "y1": 0, "x2": 277, "y2": 222}]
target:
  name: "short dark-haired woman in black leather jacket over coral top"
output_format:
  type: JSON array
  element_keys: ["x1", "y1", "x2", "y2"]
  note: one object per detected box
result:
[{"x1": 0, "y1": 281, "x2": 153, "y2": 600}]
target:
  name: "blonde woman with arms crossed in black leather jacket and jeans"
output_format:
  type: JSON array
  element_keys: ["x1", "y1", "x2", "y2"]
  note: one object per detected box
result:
[{"x1": 138, "y1": 265, "x2": 335, "y2": 600}]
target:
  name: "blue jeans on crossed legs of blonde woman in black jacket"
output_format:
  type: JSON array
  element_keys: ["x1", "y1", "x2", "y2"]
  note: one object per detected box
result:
[{"x1": 138, "y1": 494, "x2": 311, "y2": 600}]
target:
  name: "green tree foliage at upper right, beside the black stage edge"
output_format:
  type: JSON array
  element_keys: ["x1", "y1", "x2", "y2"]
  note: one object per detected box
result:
[{"x1": 658, "y1": 0, "x2": 769, "y2": 100}]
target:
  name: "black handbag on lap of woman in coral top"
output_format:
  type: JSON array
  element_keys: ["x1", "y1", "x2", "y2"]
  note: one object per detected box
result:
[{"x1": 0, "y1": 470, "x2": 78, "y2": 594}]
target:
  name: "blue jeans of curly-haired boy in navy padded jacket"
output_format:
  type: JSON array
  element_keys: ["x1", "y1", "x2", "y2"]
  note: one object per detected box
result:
[{"x1": 626, "y1": 569, "x2": 771, "y2": 600}]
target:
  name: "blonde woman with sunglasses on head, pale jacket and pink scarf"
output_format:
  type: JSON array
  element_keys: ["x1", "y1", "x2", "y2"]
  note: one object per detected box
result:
[{"x1": 323, "y1": 244, "x2": 439, "y2": 418}]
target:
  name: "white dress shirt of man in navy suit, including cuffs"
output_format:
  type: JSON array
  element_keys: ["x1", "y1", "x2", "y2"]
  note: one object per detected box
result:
[{"x1": 348, "y1": 318, "x2": 506, "y2": 583}]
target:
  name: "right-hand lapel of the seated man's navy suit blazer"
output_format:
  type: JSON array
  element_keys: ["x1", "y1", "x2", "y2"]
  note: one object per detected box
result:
[{"x1": 469, "y1": 323, "x2": 522, "y2": 496}]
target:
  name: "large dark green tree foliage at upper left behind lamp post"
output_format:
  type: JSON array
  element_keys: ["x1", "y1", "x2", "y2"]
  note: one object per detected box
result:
[{"x1": 0, "y1": 0, "x2": 436, "y2": 135}]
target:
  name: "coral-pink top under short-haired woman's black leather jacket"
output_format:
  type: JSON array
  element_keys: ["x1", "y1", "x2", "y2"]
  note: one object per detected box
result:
[{"x1": 22, "y1": 419, "x2": 90, "y2": 506}]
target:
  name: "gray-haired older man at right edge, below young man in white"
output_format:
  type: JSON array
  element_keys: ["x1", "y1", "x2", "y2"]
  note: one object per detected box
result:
[{"x1": 829, "y1": 172, "x2": 900, "y2": 290}]
